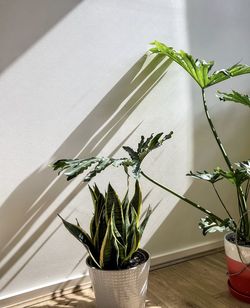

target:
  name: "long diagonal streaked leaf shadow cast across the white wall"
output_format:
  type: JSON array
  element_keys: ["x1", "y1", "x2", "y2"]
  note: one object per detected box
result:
[{"x1": 0, "y1": 55, "x2": 171, "y2": 289}]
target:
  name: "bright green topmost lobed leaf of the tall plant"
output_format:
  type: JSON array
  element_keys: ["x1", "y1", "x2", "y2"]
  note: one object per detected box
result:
[{"x1": 150, "y1": 41, "x2": 250, "y2": 89}]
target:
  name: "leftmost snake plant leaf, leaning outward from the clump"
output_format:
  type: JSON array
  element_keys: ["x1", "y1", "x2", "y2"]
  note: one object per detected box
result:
[{"x1": 57, "y1": 214, "x2": 100, "y2": 267}]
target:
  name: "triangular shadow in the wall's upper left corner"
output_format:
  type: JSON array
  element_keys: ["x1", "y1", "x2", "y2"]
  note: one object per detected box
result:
[{"x1": 0, "y1": 0, "x2": 83, "y2": 73}]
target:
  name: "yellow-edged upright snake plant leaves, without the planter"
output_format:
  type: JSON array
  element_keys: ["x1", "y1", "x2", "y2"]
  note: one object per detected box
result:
[{"x1": 59, "y1": 181, "x2": 151, "y2": 269}]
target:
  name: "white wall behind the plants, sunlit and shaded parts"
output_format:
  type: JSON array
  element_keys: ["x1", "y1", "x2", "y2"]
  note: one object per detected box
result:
[{"x1": 0, "y1": 0, "x2": 250, "y2": 301}]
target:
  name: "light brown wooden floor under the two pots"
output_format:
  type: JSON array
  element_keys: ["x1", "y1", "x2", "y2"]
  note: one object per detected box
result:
[{"x1": 11, "y1": 253, "x2": 250, "y2": 308}]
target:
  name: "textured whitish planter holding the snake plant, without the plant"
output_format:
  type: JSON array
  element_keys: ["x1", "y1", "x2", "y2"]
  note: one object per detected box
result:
[{"x1": 87, "y1": 250, "x2": 150, "y2": 308}]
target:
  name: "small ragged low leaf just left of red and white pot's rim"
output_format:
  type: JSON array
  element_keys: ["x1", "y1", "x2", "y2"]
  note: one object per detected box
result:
[{"x1": 199, "y1": 215, "x2": 234, "y2": 235}]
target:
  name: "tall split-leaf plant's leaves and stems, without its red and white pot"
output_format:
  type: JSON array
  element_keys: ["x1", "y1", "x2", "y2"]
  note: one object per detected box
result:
[{"x1": 53, "y1": 41, "x2": 250, "y2": 244}]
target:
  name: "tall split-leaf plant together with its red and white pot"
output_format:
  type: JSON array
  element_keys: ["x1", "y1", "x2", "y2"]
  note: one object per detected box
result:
[{"x1": 54, "y1": 41, "x2": 250, "y2": 302}]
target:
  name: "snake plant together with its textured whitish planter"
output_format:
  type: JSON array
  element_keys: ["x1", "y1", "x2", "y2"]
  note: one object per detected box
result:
[{"x1": 53, "y1": 176, "x2": 151, "y2": 308}]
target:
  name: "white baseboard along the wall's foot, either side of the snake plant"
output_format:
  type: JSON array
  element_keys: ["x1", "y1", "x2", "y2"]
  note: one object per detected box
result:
[{"x1": 0, "y1": 241, "x2": 223, "y2": 308}]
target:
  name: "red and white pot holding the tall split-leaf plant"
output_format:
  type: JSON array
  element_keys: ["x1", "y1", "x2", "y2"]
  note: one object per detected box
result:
[{"x1": 224, "y1": 233, "x2": 250, "y2": 303}]
